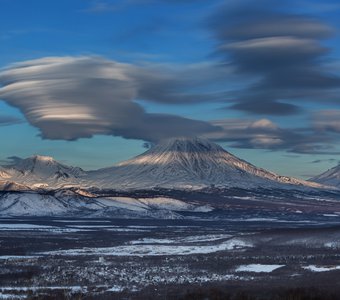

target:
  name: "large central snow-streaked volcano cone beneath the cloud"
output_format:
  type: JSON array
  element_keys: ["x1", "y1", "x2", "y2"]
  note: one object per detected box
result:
[{"x1": 89, "y1": 138, "x2": 318, "y2": 189}]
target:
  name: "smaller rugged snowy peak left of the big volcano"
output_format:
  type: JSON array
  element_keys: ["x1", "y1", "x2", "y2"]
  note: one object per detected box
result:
[{"x1": 3, "y1": 155, "x2": 84, "y2": 187}]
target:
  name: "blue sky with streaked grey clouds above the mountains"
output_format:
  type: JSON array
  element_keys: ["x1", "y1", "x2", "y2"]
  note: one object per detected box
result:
[{"x1": 0, "y1": 0, "x2": 340, "y2": 178}]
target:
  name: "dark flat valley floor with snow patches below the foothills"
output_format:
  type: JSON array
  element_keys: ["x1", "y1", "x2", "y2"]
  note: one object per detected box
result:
[{"x1": 0, "y1": 216, "x2": 340, "y2": 299}]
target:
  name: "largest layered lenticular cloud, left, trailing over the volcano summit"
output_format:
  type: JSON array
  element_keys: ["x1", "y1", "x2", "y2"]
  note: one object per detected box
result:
[{"x1": 0, "y1": 57, "x2": 218, "y2": 141}]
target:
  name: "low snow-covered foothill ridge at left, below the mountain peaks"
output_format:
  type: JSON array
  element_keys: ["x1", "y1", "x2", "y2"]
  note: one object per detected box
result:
[{"x1": 0, "y1": 191, "x2": 205, "y2": 219}]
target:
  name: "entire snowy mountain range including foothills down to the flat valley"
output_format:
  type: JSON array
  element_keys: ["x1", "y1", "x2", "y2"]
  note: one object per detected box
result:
[{"x1": 0, "y1": 138, "x2": 340, "y2": 220}]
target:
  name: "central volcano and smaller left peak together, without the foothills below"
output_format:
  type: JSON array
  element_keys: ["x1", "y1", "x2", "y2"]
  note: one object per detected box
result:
[{"x1": 0, "y1": 138, "x2": 323, "y2": 190}]
